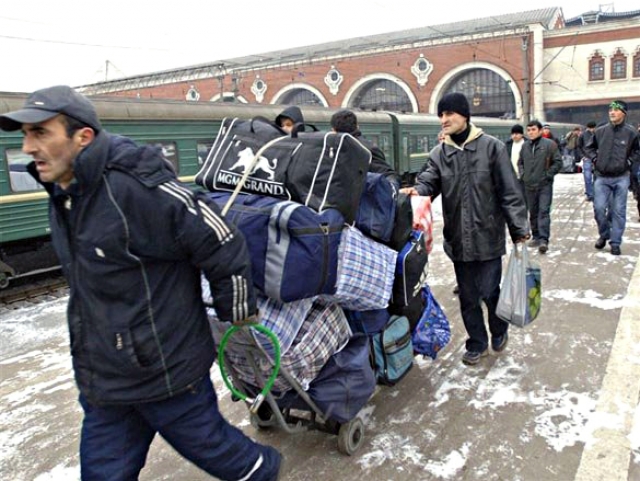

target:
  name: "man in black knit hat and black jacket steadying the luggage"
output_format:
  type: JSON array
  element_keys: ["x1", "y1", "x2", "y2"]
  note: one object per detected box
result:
[{"x1": 402, "y1": 93, "x2": 529, "y2": 365}]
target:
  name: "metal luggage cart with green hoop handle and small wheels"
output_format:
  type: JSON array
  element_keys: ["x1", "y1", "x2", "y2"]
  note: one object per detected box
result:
[{"x1": 218, "y1": 324, "x2": 365, "y2": 456}]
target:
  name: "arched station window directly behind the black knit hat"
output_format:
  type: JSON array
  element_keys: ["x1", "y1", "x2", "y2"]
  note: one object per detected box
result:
[{"x1": 445, "y1": 69, "x2": 516, "y2": 119}]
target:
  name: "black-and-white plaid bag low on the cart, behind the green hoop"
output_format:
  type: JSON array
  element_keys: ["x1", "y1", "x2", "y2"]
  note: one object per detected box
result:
[{"x1": 213, "y1": 299, "x2": 352, "y2": 393}]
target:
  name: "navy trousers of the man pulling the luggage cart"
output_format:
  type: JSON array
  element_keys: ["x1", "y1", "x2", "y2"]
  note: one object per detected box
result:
[{"x1": 80, "y1": 377, "x2": 280, "y2": 481}]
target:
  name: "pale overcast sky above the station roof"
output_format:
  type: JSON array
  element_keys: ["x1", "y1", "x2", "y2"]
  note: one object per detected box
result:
[{"x1": 0, "y1": 0, "x2": 640, "y2": 92}]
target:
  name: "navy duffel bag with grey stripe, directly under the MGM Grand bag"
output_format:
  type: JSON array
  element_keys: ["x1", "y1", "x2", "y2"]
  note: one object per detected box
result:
[{"x1": 208, "y1": 192, "x2": 344, "y2": 302}]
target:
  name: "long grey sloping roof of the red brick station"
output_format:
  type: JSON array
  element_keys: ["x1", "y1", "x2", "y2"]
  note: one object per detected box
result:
[{"x1": 79, "y1": 7, "x2": 562, "y2": 93}]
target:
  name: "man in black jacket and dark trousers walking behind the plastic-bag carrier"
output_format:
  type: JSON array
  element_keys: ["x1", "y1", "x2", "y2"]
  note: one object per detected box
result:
[{"x1": 518, "y1": 120, "x2": 562, "y2": 254}]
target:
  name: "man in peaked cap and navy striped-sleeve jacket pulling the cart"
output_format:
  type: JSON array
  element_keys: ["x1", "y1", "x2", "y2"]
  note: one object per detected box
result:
[{"x1": 0, "y1": 86, "x2": 281, "y2": 481}]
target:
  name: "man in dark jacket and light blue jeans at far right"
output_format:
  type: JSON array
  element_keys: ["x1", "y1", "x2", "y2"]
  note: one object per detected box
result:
[{"x1": 584, "y1": 100, "x2": 640, "y2": 256}]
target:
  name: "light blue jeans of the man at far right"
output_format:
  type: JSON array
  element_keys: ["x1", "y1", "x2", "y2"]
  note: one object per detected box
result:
[{"x1": 593, "y1": 173, "x2": 630, "y2": 247}]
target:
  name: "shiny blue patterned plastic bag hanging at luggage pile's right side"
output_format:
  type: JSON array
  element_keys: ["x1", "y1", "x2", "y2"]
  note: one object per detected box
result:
[{"x1": 411, "y1": 286, "x2": 451, "y2": 359}]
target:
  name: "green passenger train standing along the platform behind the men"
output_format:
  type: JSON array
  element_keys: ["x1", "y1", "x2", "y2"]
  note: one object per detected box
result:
[{"x1": 0, "y1": 93, "x2": 572, "y2": 288}]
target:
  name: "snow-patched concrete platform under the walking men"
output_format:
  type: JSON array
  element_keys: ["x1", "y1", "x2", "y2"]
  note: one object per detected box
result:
[{"x1": 0, "y1": 174, "x2": 640, "y2": 481}]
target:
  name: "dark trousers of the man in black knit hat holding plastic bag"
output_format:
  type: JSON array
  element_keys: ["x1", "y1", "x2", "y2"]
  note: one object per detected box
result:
[{"x1": 453, "y1": 257, "x2": 509, "y2": 352}]
